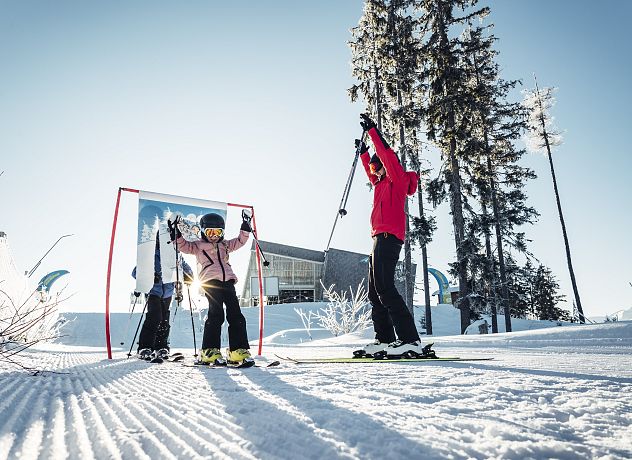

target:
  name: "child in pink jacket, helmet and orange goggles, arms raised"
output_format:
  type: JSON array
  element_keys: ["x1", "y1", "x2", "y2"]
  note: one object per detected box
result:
[{"x1": 168, "y1": 213, "x2": 252, "y2": 365}]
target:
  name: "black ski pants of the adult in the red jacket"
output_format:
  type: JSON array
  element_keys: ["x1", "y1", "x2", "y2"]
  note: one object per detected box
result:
[{"x1": 369, "y1": 233, "x2": 419, "y2": 343}]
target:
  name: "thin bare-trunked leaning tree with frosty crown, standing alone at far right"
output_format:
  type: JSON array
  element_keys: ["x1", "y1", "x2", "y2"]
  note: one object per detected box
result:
[{"x1": 523, "y1": 79, "x2": 586, "y2": 324}]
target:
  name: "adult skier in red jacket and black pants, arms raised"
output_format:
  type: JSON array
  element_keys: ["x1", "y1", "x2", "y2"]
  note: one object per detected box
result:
[{"x1": 354, "y1": 114, "x2": 423, "y2": 356}]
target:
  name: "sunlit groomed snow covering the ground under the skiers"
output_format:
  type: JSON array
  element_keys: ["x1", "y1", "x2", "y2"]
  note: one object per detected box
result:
[{"x1": 0, "y1": 304, "x2": 632, "y2": 459}]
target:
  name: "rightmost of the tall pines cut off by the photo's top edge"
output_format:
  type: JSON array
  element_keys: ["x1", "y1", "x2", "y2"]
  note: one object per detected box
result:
[{"x1": 417, "y1": 0, "x2": 489, "y2": 333}]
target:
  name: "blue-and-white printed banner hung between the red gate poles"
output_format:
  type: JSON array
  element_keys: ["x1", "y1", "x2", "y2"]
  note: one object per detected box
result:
[{"x1": 136, "y1": 191, "x2": 226, "y2": 293}]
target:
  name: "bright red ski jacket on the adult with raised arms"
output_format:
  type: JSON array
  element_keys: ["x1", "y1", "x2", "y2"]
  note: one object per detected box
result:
[{"x1": 360, "y1": 128, "x2": 419, "y2": 241}]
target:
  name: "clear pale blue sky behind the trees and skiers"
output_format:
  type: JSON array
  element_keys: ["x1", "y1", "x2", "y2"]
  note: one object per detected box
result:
[{"x1": 0, "y1": 0, "x2": 632, "y2": 315}]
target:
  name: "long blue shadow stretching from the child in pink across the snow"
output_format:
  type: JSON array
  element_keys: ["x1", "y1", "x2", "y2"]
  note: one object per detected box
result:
[{"x1": 206, "y1": 368, "x2": 440, "y2": 459}]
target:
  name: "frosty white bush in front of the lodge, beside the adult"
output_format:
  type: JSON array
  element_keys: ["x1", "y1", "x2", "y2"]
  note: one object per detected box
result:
[{"x1": 314, "y1": 280, "x2": 371, "y2": 336}]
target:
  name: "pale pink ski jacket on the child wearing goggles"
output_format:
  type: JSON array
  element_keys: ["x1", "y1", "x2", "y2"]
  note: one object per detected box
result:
[{"x1": 176, "y1": 230, "x2": 250, "y2": 286}]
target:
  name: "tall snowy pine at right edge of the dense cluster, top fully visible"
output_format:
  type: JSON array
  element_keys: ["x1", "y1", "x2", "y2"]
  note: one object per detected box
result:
[{"x1": 461, "y1": 20, "x2": 537, "y2": 332}]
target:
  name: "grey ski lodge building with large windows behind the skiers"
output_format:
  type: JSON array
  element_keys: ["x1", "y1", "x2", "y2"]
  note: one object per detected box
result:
[{"x1": 241, "y1": 241, "x2": 416, "y2": 306}]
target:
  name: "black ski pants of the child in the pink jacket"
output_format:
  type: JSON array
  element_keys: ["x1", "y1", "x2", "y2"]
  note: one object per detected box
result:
[{"x1": 202, "y1": 280, "x2": 250, "y2": 350}]
